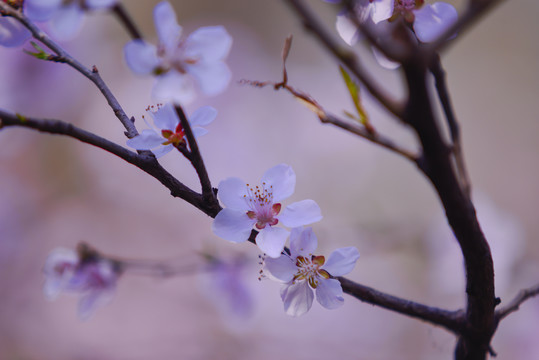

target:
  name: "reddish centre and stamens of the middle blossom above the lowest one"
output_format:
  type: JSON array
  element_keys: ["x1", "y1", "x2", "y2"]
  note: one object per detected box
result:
[{"x1": 243, "y1": 182, "x2": 281, "y2": 230}]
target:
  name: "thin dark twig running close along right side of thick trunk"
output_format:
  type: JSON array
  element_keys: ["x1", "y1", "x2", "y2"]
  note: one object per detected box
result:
[{"x1": 430, "y1": 54, "x2": 471, "y2": 197}]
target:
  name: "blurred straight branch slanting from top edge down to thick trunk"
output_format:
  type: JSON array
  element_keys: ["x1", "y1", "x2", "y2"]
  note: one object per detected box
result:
[{"x1": 285, "y1": 0, "x2": 404, "y2": 118}]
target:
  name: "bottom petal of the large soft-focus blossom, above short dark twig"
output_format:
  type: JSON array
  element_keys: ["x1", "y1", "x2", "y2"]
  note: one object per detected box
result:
[{"x1": 152, "y1": 70, "x2": 195, "y2": 105}]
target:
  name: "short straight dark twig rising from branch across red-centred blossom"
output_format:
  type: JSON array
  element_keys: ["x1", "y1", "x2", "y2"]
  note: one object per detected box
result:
[{"x1": 175, "y1": 106, "x2": 219, "y2": 207}]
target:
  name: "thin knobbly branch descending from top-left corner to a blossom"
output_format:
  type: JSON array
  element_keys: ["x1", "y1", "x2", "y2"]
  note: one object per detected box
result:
[{"x1": 0, "y1": 1, "x2": 138, "y2": 138}]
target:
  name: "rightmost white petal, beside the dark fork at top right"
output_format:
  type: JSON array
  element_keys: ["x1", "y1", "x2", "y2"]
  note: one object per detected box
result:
[{"x1": 414, "y1": 1, "x2": 458, "y2": 43}]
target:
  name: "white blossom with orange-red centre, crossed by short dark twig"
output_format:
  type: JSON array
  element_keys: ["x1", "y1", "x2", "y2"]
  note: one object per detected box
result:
[{"x1": 126, "y1": 104, "x2": 217, "y2": 157}]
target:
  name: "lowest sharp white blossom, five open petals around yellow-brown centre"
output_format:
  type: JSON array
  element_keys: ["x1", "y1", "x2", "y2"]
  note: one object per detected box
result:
[{"x1": 265, "y1": 228, "x2": 359, "y2": 316}]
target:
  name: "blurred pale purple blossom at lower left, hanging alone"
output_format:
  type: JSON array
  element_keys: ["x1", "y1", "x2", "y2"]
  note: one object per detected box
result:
[{"x1": 43, "y1": 248, "x2": 119, "y2": 319}]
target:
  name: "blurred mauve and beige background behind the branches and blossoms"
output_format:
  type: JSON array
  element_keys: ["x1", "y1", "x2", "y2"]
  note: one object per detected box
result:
[{"x1": 0, "y1": 0, "x2": 539, "y2": 360}]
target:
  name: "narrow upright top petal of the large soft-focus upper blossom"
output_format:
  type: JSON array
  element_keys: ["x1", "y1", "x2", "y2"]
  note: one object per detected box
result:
[{"x1": 153, "y1": 1, "x2": 182, "y2": 51}]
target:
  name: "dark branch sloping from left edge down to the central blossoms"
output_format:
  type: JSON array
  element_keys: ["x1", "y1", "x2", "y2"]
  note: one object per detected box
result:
[{"x1": 0, "y1": 109, "x2": 221, "y2": 217}]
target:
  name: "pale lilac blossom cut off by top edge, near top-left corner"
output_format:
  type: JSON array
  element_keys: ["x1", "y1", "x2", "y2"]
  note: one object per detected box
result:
[{"x1": 24, "y1": 0, "x2": 116, "y2": 40}]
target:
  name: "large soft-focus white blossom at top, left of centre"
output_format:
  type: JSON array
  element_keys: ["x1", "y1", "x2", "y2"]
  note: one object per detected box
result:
[{"x1": 124, "y1": 1, "x2": 232, "y2": 104}]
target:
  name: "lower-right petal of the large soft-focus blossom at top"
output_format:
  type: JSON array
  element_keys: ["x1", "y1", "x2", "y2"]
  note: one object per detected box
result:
[{"x1": 186, "y1": 61, "x2": 232, "y2": 96}]
